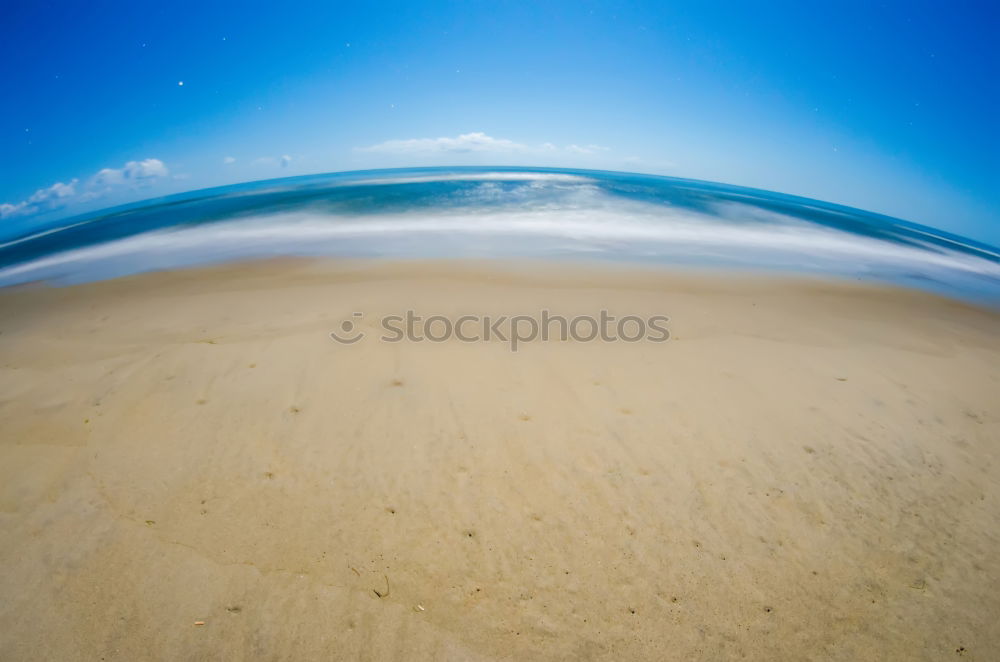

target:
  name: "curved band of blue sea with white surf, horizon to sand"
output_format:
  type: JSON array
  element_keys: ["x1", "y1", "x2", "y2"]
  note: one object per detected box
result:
[{"x1": 0, "y1": 167, "x2": 1000, "y2": 306}]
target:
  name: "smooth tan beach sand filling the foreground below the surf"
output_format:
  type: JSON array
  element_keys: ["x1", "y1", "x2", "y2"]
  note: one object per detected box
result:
[{"x1": 0, "y1": 261, "x2": 1000, "y2": 660}]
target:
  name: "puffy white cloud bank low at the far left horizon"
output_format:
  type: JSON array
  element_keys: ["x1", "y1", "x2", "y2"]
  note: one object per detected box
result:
[{"x1": 0, "y1": 159, "x2": 170, "y2": 218}]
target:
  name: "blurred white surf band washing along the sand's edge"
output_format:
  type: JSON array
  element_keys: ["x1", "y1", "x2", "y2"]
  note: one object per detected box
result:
[{"x1": 0, "y1": 200, "x2": 1000, "y2": 284}]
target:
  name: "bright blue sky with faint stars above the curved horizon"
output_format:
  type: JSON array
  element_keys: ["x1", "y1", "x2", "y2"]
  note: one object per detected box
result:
[{"x1": 0, "y1": 0, "x2": 1000, "y2": 244}]
